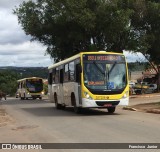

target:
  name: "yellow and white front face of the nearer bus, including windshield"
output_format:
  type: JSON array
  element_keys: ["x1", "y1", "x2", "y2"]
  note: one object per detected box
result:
[{"x1": 82, "y1": 54, "x2": 129, "y2": 107}]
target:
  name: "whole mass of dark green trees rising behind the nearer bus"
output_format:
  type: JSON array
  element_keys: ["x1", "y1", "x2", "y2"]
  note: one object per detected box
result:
[{"x1": 13, "y1": 0, "x2": 160, "y2": 90}]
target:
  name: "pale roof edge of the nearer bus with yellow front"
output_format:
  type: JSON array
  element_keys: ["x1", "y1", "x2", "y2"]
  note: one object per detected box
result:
[{"x1": 48, "y1": 51, "x2": 123, "y2": 69}]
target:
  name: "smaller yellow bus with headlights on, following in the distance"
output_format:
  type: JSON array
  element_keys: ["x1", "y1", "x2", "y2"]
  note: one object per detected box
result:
[{"x1": 17, "y1": 77, "x2": 44, "y2": 100}]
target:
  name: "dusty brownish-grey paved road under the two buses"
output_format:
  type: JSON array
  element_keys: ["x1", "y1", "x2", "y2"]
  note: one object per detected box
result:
[{"x1": 0, "y1": 98, "x2": 160, "y2": 151}]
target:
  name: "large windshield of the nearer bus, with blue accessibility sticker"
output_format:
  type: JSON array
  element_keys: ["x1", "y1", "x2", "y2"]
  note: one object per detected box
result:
[{"x1": 83, "y1": 54, "x2": 127, "y2": 91}]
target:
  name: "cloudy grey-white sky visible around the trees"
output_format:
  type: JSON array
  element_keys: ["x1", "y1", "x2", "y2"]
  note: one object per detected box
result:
[{"x1": 0, "y1": 0, "x2": 143, "y2": 67}]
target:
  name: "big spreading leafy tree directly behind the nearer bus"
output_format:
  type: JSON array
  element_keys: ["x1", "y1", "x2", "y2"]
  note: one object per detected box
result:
[{"x1": 14, "y1": 0, "x2": 132, "y2": 61}]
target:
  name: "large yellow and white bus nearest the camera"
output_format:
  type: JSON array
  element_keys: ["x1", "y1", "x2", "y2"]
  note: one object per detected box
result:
[{"x1": 48, "y1": 51, "x2": 129, "y2": 113}]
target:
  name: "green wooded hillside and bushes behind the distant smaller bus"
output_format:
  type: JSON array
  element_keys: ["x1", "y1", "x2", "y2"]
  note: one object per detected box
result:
[{"x1": 0, "y1": 67, "x2": 48, "y2": 96}]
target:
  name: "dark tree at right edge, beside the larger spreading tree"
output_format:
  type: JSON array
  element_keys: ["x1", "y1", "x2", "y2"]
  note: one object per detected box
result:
[{"x1": 129, "y1": 0, "x2": 160, "y2": 90}]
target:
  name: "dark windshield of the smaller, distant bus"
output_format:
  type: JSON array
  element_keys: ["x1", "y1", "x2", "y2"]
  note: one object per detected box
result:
[{"x1": 26, "y1": 79, "x2": 43, "y2": 93}]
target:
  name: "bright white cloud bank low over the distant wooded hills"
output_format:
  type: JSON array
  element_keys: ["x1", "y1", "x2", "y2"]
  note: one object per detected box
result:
[{"x1": 0, "y1": 41, "x2": 53, "y2": 67}]
